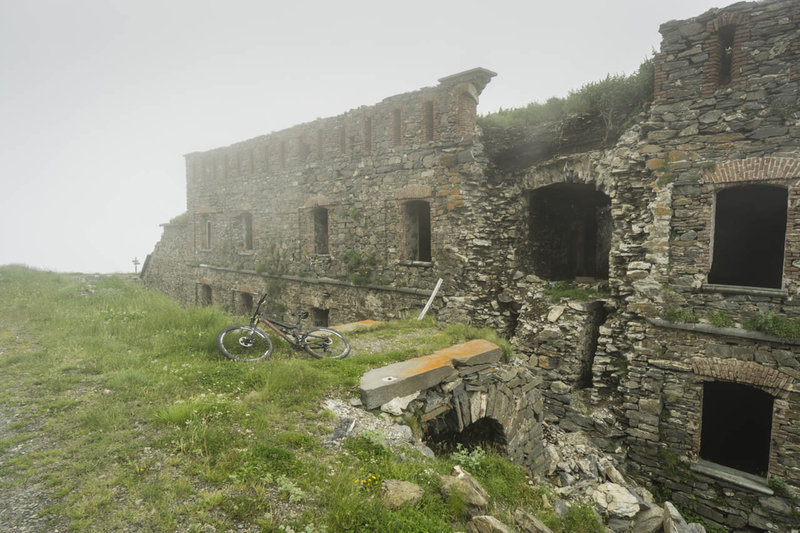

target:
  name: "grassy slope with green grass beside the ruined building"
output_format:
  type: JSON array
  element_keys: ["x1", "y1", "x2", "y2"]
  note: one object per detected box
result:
[{"x1": 0, "y1": 266, "x2": 597, "y2": 532}]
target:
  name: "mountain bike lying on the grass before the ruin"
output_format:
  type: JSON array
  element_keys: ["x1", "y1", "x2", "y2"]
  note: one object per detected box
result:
[{"x1": 217, "y1": 294, "x2": 350, "y2": 361}]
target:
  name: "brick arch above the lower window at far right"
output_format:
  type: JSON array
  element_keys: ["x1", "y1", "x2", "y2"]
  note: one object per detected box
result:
[{"x1": 691, "y1": 357, "x2": 795, "y2": 398}]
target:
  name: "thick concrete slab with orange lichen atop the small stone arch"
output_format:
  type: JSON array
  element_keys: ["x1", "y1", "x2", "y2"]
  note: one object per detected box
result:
[{"x1": 360, "y1": 339, "x2": 502, "y2": 409}]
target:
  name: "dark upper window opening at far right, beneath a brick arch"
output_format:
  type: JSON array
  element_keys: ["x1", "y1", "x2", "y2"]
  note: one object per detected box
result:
[{"x1": 708, "y1": 185, "x2": 789, "y2": 289}]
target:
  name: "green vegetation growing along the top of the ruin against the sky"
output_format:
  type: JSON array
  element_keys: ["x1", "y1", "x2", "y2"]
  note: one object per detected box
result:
[{"x1": 479, "y1": 58, "x2": 654, "y2": 138}]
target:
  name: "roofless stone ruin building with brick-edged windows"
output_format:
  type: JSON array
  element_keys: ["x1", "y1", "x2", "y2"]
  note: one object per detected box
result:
[{"x1": 142, "y1": 0, "x2": 800, "y2": 531}]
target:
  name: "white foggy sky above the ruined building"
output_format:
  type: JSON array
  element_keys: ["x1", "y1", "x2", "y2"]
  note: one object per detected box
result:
[{"x1": 0, "y1": 0, "x2": 730, "y2": 272}]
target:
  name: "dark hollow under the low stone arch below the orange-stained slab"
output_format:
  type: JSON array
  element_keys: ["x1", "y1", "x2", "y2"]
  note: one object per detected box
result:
[{"x1": 424, "y1": 411, "x2": 507, "y2": 455}]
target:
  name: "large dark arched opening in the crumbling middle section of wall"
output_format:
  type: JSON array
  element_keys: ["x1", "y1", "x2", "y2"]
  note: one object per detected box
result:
[{"x1": 528, "y1": 183, "x2": 612, "y2": 281}]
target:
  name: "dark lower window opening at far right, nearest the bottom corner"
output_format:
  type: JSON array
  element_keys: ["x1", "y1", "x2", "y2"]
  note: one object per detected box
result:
[{"x1": 700, "y1": 381, "x2": 773, "y2": 477}]
